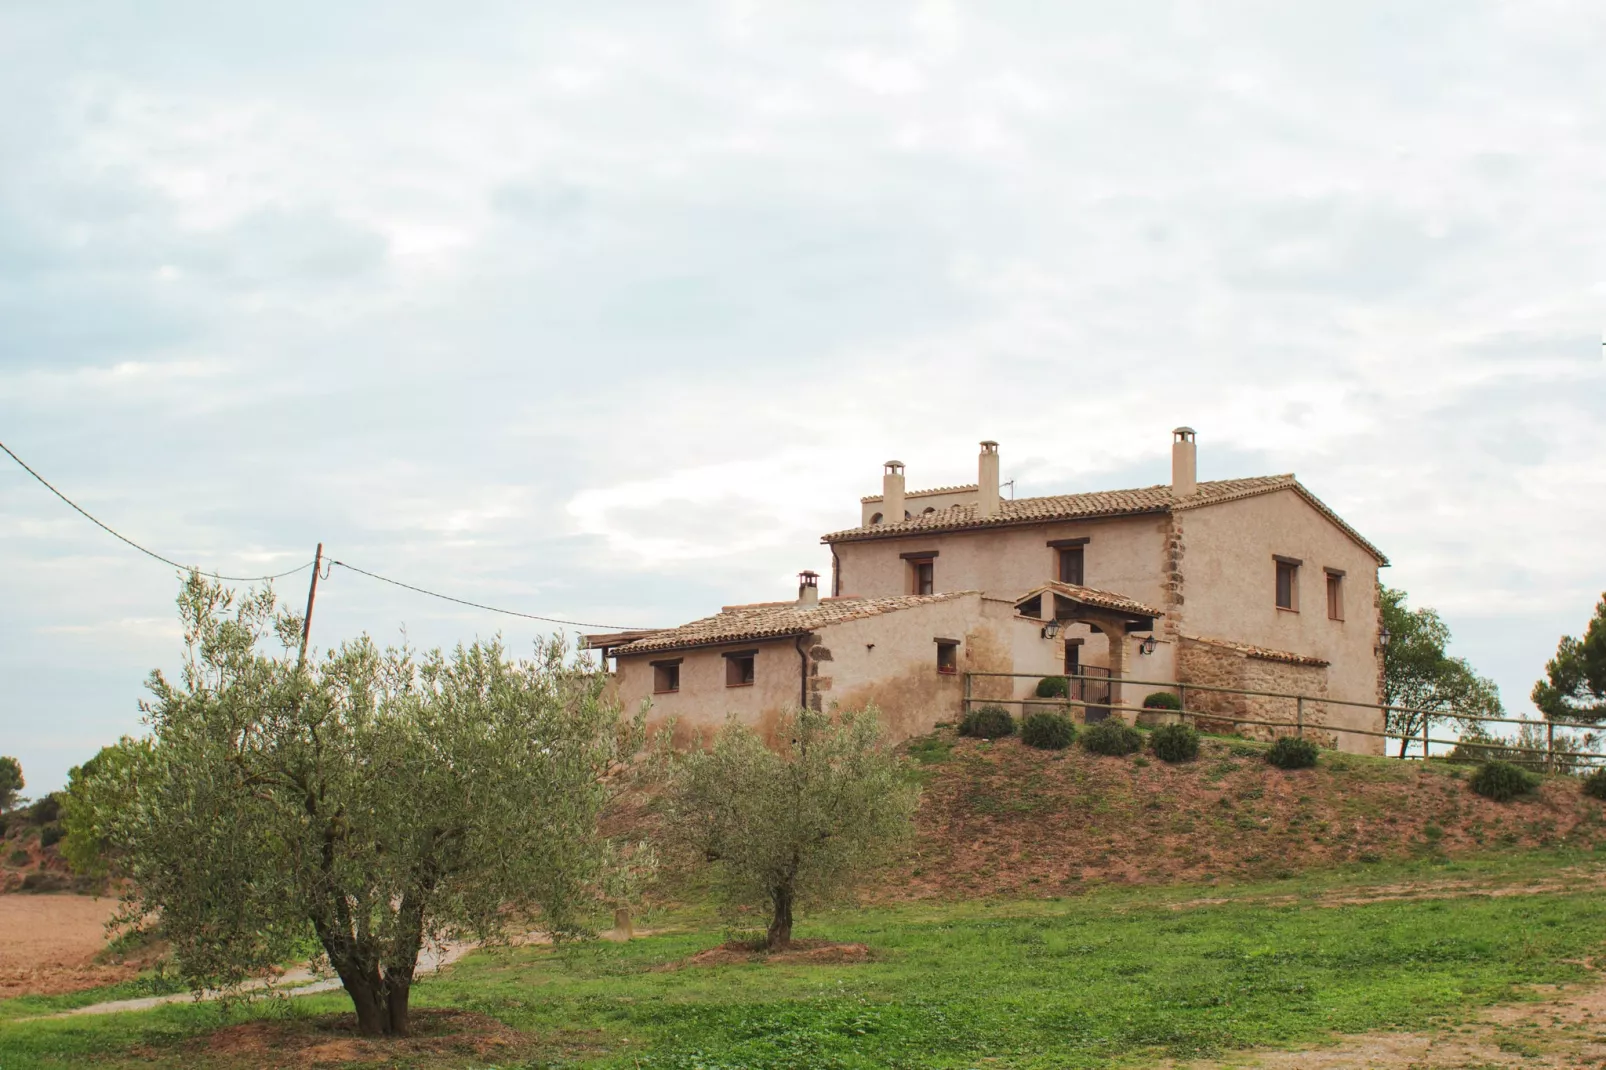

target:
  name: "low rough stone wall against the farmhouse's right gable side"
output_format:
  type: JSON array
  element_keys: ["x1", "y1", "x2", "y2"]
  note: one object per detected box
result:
[{"x1": 1177, "y1": 638, "x2": 1336, "y2": 747}]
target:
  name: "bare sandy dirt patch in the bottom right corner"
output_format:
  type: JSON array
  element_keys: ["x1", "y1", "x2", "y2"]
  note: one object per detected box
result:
[{"x1": 1166, "y1": 988, "x2": 1606, "y2": 1070}]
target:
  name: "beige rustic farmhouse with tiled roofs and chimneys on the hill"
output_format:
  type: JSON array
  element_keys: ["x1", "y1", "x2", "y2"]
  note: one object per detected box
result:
[{"x1": 586, "y1": 427, "x2": 1388, "y2": 753}]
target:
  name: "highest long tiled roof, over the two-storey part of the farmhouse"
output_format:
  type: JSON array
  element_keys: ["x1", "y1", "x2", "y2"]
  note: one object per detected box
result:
[{"x1": 821, "y1": 474, "x2": 1389, "y2": 564}]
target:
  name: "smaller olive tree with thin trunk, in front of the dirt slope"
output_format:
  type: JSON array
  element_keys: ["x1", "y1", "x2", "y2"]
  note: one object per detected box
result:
[{"x1": 663, "y1": 707, "x2": 919, "y2": 950}]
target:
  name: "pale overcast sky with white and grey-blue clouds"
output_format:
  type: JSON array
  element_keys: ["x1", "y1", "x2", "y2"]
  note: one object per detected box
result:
[{"x1": 0, "y1": 0, "x2": 1606, "y2": 792}]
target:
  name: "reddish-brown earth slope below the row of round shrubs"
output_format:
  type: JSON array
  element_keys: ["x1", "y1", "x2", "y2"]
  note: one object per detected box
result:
[{"x1": 877, "y1": 729, "x2": 1606, "y2": 898}]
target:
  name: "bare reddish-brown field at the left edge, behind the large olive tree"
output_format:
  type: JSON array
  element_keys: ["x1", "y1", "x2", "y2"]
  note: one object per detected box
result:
[{"x1": 0, "y1": 895, "x2": 138, "y2": 999}]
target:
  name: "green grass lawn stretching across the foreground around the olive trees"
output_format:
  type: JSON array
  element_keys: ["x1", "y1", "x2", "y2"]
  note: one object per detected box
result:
[{"x1": 0, "y1": 855, "x2": 1606, "y2": 1070}]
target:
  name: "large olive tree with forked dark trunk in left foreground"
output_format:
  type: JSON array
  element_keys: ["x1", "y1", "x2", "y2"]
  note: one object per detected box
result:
[{"x1": 103, "y1": 575, "x2": 639, "y2": 1035}]
